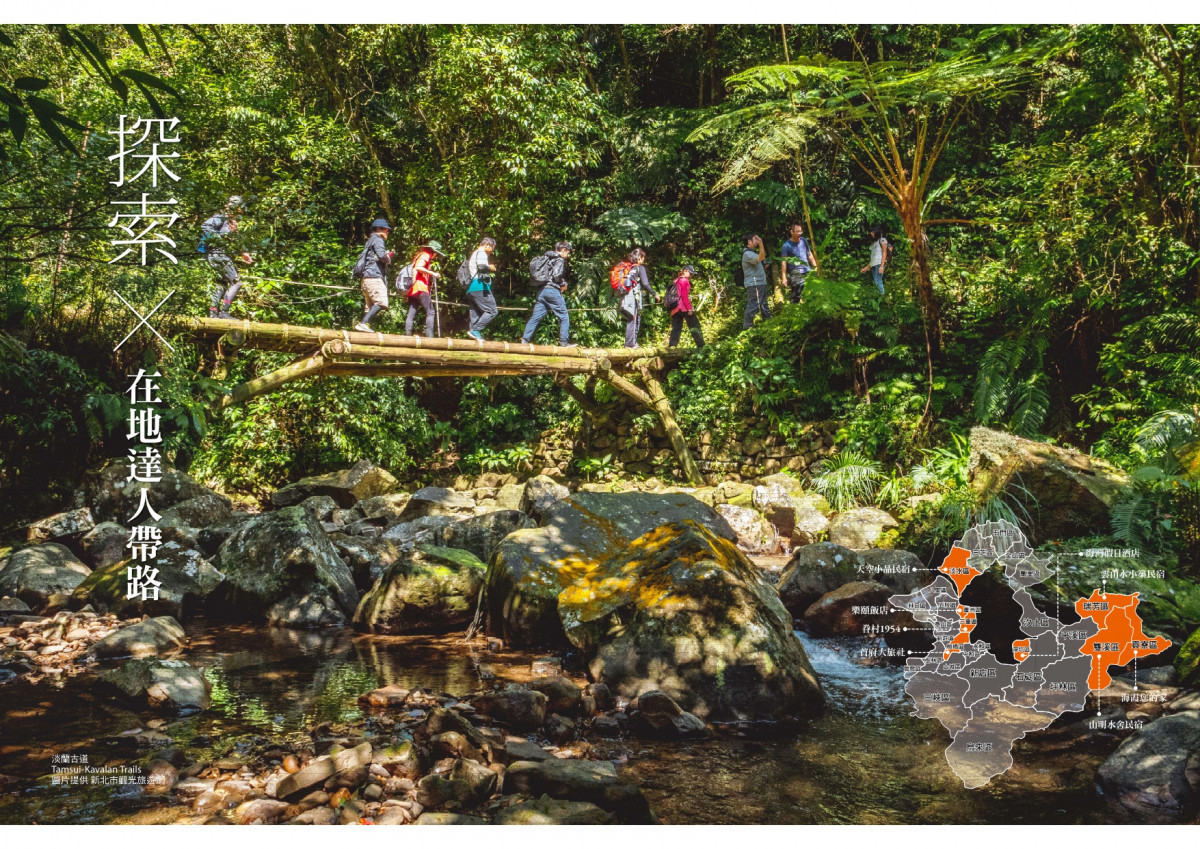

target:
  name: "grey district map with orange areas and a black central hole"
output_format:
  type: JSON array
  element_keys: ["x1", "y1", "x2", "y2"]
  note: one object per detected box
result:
[{"x1": 890, "y1": 522, "x2": 1171, "y2": 789}]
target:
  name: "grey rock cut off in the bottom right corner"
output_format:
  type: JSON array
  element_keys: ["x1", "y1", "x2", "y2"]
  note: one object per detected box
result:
[{"x1": 1098, "y1": 710, "x2": 1200, "y2": 823}]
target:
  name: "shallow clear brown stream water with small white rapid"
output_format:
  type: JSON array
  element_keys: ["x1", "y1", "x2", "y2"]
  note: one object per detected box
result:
[{"x1": 0, "y1": 622, "x2": 1115, "y2": 823}]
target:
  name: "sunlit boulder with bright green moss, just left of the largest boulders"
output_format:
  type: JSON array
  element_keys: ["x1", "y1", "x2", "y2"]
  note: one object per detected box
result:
[{"x1": 354, "y1": 546, "x2": 487, "y2": 634}]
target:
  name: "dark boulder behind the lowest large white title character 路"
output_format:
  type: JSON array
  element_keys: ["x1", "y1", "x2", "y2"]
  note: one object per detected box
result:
[{"x1": 71, "y1": 542, "x2": 224, "y2": 619}]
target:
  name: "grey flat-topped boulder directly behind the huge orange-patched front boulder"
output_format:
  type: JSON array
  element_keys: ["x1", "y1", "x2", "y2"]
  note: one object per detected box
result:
[{"x1": 486, "y1": 492, "x2": 737, "y2": 645}]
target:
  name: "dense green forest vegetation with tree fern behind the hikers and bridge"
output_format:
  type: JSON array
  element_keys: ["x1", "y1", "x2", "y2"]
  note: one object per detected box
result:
[{"x1": 0, "y1": 25, "x2": 1200, "y2": 573}]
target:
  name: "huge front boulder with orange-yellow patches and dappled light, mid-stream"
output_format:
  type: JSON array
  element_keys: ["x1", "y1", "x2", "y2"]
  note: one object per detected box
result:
[{"x1": 558, "y1": 522, "x2": 824, "y2": 719}]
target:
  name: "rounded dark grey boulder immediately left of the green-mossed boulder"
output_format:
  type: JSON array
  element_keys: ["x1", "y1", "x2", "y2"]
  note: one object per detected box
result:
[{"x1": 214, "y1": 506, "x2": 359, "y2": 628}]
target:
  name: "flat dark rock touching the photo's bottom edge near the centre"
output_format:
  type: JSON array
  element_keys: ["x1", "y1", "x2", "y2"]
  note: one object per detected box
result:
[{"x1": 504, "y1": 758, "x2": 653, "y2": 825}]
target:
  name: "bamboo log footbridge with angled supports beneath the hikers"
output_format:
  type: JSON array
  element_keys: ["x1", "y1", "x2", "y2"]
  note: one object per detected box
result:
[{"x1": 172, "y1": 318, "x2": 703, "y2": 483}]
